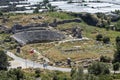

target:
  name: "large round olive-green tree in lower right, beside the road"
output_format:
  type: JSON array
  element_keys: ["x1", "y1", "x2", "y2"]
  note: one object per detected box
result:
[{"x1": 88, "y1": 62, "x2": 110, "y2": 75}]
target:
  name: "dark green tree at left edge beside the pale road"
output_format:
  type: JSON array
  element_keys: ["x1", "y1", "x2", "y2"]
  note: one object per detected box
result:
[{"x1": 0, "y1": 50, "x2": 9, "y2": 70}]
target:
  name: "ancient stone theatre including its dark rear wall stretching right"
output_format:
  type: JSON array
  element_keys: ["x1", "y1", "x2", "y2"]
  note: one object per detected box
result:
[{"x1": 11, "y1": 19, "x2": 81, "y2": 45}]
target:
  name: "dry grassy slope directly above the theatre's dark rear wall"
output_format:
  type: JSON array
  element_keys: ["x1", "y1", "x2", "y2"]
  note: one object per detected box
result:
[{"x1": 0, "y1": 12, "x2": 74, "y2": 28}]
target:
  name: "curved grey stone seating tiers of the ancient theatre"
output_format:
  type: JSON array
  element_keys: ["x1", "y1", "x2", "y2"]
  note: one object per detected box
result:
[{"x1": 12, "y1": 30, "x2": 65, "y2": 45}]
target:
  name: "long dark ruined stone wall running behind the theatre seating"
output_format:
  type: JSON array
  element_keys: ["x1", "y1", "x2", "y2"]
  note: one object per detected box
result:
[{"x1": 11, "y1": 19, "x2": 81, "y2": 33}]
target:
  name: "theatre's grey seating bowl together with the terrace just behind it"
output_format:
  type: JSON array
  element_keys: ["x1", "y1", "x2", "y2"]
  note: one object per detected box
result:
[{"x1": 12, "y1": 24, "x2": 65, "y2": 45}]
